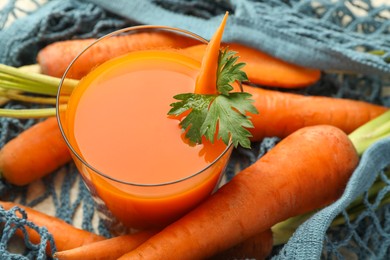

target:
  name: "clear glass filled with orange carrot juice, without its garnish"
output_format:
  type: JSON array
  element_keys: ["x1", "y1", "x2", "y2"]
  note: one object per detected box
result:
[{"x1": 57, "y1": 26, "x2": 232, "y2": 233}]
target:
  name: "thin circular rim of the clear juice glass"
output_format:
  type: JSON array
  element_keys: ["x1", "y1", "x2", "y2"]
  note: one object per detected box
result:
[{"x1": 56, "y1": 25, "x2": 233, "y2": 187}]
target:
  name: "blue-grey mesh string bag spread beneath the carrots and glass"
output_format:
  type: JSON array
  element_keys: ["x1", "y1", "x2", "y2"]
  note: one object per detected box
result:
[{"x1": 0, "y1": 0, "x2": 390, "y2": 259}]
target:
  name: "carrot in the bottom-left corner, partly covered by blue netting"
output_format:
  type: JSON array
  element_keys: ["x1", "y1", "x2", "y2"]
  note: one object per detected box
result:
[{"x1": 0, "y1": 201, "x2": 105, "y2": 252}]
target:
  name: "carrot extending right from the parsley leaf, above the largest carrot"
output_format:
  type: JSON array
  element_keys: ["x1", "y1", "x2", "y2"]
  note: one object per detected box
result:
[{"x1": 244, "y1": 85, "x2": 388, "y2": 141}]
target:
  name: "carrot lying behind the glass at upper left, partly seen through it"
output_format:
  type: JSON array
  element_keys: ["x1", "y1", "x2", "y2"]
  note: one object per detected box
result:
[{"x1": 37, "y1": 31, "x2": 199, "y2": 79}]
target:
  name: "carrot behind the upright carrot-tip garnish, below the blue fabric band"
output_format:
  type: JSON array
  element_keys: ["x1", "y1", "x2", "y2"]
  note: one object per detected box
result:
[{"x1": 183, "y1": 43, "x2": 321, "y2": 88}]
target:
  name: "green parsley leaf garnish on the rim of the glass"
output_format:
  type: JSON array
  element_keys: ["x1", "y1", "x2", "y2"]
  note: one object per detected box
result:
[{"x1": 168, "y1": 48, "x2": 258, "y2": 148}]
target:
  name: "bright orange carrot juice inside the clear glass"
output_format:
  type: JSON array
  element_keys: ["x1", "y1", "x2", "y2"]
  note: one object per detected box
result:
[{"x1": 65, "y1": 51, "x2": 228, "y2": 228}]
